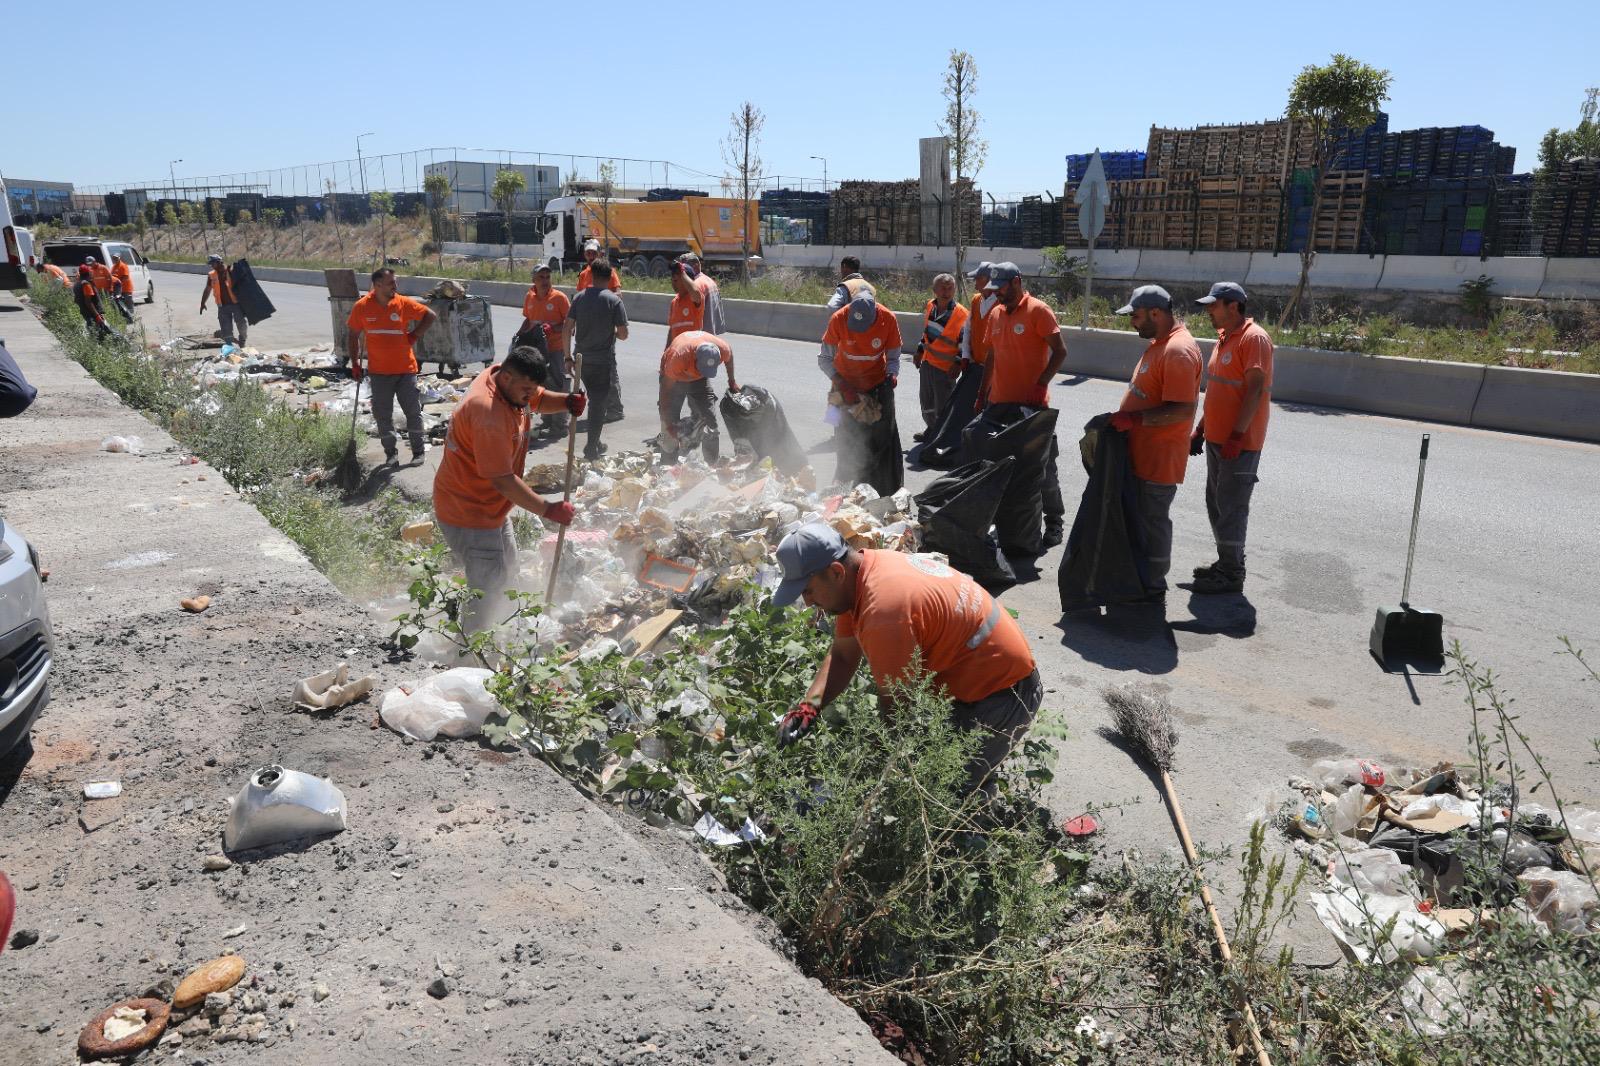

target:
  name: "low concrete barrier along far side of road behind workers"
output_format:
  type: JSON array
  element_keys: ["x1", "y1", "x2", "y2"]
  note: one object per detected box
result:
[{"x1": 150, "y1": 264, "x2": 1600, "y2": 442}]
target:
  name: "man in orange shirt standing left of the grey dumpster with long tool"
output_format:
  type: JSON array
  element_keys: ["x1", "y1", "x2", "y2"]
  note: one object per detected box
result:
[{"x1": 347, "y1": 267, "x2": 438, "y2": 463}]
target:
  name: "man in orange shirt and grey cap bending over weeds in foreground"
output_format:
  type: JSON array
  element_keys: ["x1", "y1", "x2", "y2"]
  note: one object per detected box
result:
[{"x1": 773, "y1": 522, "x2": 1043, "y2": 794}]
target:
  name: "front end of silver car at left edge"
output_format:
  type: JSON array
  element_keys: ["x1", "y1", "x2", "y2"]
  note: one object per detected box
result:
[{"x1": 0, "y1": 519, "x2": 56, "y2": 755}]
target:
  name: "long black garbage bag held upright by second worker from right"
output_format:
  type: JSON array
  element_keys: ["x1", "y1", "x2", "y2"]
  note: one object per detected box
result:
[{"x1": 1056, "y1": 427, "x2": 1146, "y2": 611}]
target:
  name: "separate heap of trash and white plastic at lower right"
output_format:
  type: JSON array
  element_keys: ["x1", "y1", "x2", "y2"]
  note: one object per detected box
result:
[{"x1": 1290, "y1": 759, "x2": 1600, "y2": 1032}]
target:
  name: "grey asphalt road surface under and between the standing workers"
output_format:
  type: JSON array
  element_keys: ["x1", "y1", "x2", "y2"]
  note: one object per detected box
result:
[{"x1": 147, "y1": 274, "x2": 1600, "y2": 883}]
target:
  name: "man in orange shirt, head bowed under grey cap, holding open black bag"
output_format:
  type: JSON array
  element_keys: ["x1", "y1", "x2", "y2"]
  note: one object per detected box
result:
[{"x1": 816, "y1": 291, "x2": 906, "y2": 496}]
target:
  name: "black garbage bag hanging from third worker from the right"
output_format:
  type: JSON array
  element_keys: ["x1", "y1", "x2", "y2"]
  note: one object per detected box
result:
[{"x1": 962, "y1": 403, "x2": 1056, "y2": 555}]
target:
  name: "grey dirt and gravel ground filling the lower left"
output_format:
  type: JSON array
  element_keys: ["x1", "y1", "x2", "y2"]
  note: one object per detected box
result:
[{"x1": 0, "y1": 296, "x2": 891, "y2": 1066}]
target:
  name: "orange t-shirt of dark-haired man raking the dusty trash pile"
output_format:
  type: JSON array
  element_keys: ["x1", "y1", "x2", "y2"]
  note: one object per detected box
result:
[{"x1": 434, "y1": 367, "x2": 544, "y2": 530}]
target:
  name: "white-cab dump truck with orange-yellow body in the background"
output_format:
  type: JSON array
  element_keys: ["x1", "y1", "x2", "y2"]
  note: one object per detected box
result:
[{"x1": 541, "y1": 197, "x2": 762, "y2": 277}]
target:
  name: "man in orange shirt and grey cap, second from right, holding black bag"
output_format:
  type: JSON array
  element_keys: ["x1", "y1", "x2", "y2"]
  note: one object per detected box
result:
[{"x1": 1096, "y1": 285, "x2": 1202, "y2": 605}]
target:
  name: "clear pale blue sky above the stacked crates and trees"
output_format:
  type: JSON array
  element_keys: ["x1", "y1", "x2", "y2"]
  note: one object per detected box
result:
[{"x1": 0, "y1": 0, "x2": 1600, "y2": 198}]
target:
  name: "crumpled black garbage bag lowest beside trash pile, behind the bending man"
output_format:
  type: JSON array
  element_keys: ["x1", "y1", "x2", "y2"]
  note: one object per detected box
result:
[{"x1": 915, "y1": 456, "x2": 1016, "y2": 592}]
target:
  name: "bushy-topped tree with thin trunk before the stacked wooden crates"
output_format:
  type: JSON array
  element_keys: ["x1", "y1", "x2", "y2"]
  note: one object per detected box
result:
[{"x1": 1283, "y1": 53, "x2": 1394, "y2": 322}]
